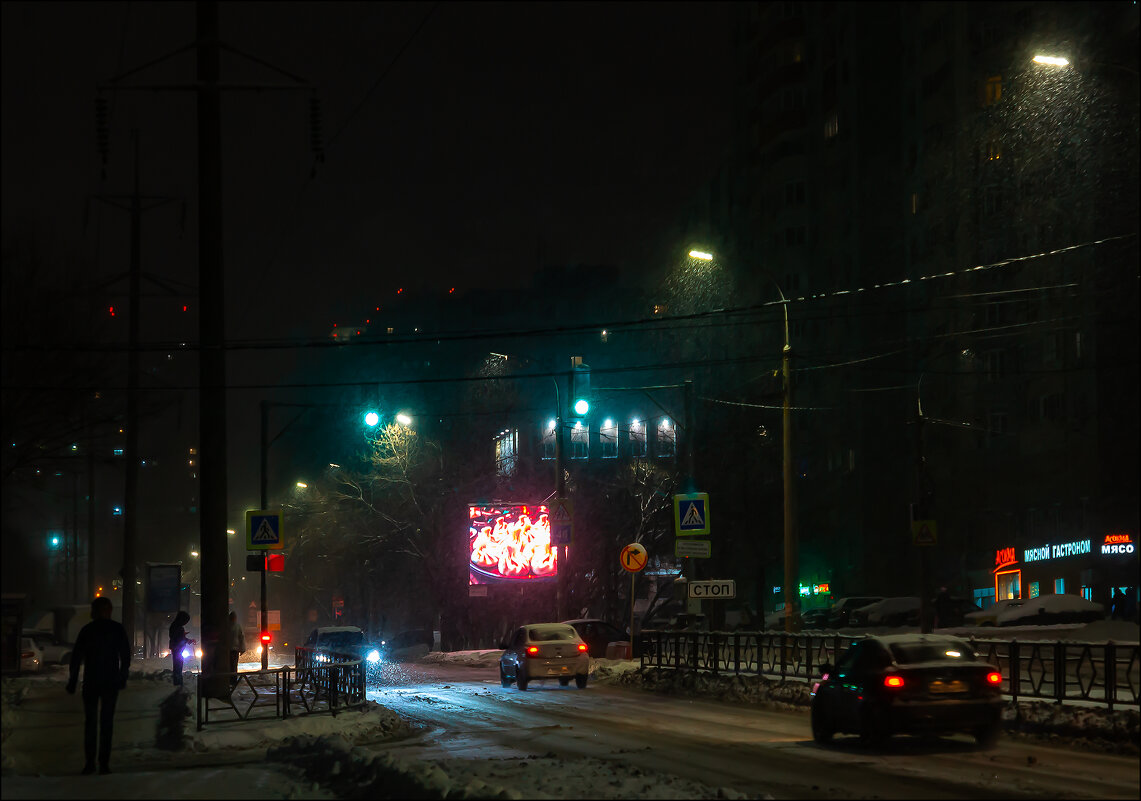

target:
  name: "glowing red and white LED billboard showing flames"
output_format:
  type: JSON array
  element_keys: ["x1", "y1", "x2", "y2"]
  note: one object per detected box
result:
[{"x1": 468, "y1": 503, "x2": 558, "y2": 584}]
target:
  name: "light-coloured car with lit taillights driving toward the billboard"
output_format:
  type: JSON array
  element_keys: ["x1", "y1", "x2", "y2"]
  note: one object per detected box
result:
[{"x1": 500, "y1": 623, "x2": 590, "y2": 690}]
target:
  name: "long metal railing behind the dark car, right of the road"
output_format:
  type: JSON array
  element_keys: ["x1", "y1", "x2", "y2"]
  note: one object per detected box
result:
[{"x1": 639, "y1": 631, "x2": 1141, "y2": 710}]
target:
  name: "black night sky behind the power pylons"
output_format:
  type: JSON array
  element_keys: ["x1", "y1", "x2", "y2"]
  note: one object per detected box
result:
[{"x1": 2, "y1": 2, "x2": 731, "y2": 339}]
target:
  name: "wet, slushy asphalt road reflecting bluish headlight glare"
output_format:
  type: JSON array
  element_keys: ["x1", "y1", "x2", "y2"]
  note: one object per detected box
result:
[{"x1": 369, "y1": 664, "x2": 1141, "y2": 799}]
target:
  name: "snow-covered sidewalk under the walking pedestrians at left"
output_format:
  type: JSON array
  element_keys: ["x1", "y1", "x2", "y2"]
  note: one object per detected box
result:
[{"x1": 0, "y1": 668, "x2": 403, "y2": 801}]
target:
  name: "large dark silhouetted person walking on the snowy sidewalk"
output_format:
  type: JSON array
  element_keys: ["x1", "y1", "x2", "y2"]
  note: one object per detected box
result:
[{"x1": 67, "y1": 596, "x2": 131, "y2": 775}]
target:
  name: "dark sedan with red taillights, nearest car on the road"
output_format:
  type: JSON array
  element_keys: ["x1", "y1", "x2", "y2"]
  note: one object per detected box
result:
[{"x1": 810, "y1": 634, "x2": 1003, "y2": 747}]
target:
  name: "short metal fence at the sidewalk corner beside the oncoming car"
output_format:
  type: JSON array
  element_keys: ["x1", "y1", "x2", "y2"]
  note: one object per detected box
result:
[{"x1": 195, "y1": 648, "x2": 365, "y2": 731}]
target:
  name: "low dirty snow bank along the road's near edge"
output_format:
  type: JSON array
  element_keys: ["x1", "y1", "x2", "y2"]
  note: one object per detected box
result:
[{"x1": 267, "y1": 735, "x2": 771, "y2": 799}]
